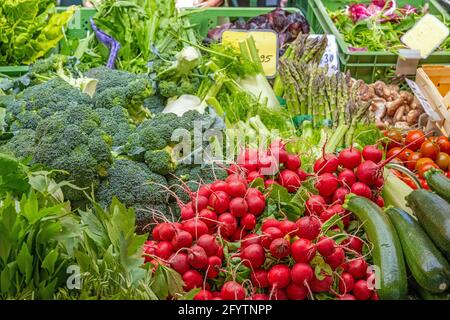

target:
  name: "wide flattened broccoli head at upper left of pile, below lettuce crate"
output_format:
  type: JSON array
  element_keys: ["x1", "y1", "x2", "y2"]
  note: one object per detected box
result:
[{"x1": 3, "y1": 78, "x2": 92, "y2": 131}]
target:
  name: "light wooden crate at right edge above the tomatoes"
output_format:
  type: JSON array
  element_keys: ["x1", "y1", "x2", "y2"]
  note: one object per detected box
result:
[{"x1": 416, "y1": 65, "x2": 450, "y2": 135}]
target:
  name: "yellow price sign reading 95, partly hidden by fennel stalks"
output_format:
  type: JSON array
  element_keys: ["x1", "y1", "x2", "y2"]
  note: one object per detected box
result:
[{"x1": 222, "y1": 29, "x2": 278, "y2": 78}]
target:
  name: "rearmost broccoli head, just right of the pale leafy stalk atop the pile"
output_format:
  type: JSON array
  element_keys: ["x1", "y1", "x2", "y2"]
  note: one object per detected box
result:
[{"x1": 86, "y1": 67, "x2": 154, "y2": 124}]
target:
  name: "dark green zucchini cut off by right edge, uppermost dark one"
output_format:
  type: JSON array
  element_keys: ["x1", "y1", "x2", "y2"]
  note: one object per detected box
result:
[{"x1": 406, "y1": 189, "x2": 450, "y2": 259}]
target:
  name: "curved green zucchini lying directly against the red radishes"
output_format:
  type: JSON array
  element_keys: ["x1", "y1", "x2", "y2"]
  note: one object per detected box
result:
[{"x1": 344, "y1": 194, "x2": 408, "y2": 300}]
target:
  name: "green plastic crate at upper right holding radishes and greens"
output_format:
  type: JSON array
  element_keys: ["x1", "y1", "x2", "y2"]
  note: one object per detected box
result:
[{"x1": 307, "y1": 0, "x2": 450, "y2": 83}]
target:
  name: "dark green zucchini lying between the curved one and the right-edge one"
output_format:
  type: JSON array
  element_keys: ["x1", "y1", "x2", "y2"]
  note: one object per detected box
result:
[{"x1": 386, "y1": 208, "x2": 450, "y2": 293}]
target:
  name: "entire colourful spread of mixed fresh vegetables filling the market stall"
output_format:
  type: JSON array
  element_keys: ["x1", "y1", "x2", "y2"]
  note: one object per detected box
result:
[{"x1": 0, "y1": 0, "x2": 450, "y2": 300}]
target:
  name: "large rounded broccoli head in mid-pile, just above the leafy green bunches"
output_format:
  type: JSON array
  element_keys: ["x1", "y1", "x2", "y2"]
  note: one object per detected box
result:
[{"x1": 33, "y1": 105, "x2": 112, "y2": 200}]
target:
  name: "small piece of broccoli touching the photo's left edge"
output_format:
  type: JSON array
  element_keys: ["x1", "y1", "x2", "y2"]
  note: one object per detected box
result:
[{"x1": 0, "y1": 129, "x2": 35, "y2": 160}]
